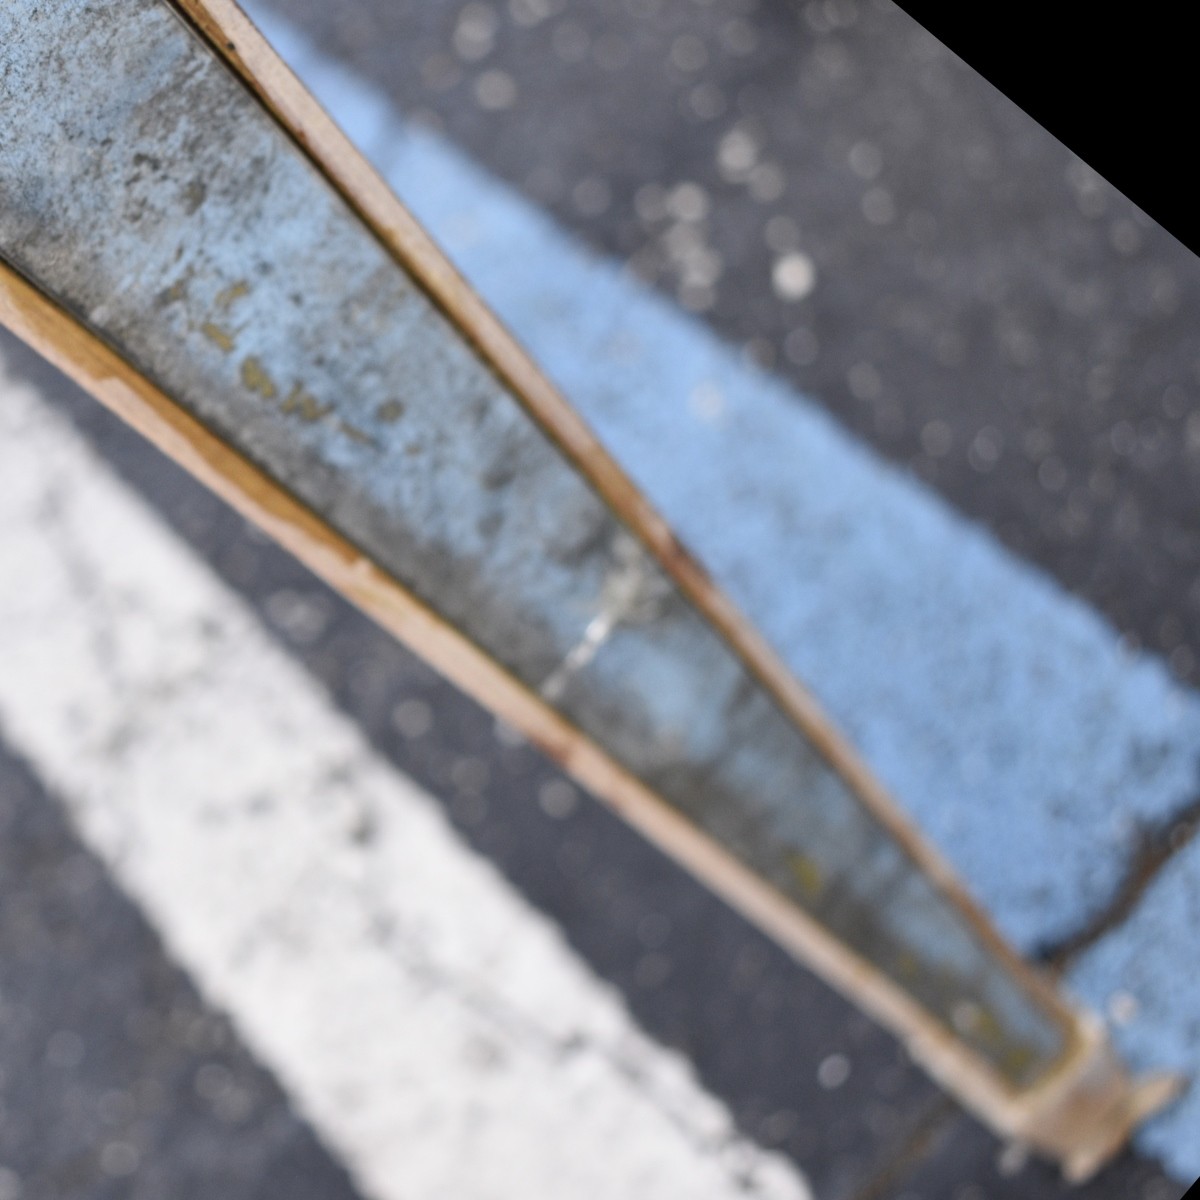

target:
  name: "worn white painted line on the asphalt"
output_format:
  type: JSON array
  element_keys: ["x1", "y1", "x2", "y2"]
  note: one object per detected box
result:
[{"x1": 0, "y1": 364, "x2": 809, "y2": 1200}]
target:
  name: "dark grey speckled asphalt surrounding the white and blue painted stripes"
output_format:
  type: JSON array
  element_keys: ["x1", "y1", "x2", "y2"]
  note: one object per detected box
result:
[{"x1": 0, "y1": 0, "x2": 1200, "y2": 1200}]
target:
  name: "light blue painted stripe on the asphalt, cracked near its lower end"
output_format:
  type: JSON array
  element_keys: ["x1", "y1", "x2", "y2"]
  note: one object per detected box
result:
[{"x1": 246, "y1": 6, "x2": 1200, "y2": 1177}]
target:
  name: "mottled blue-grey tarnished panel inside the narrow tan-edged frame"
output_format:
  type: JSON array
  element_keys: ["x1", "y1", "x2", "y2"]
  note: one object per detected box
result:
[{"x1": 0, "y1": 0, "x2": 1180, "y2": 1180}]
